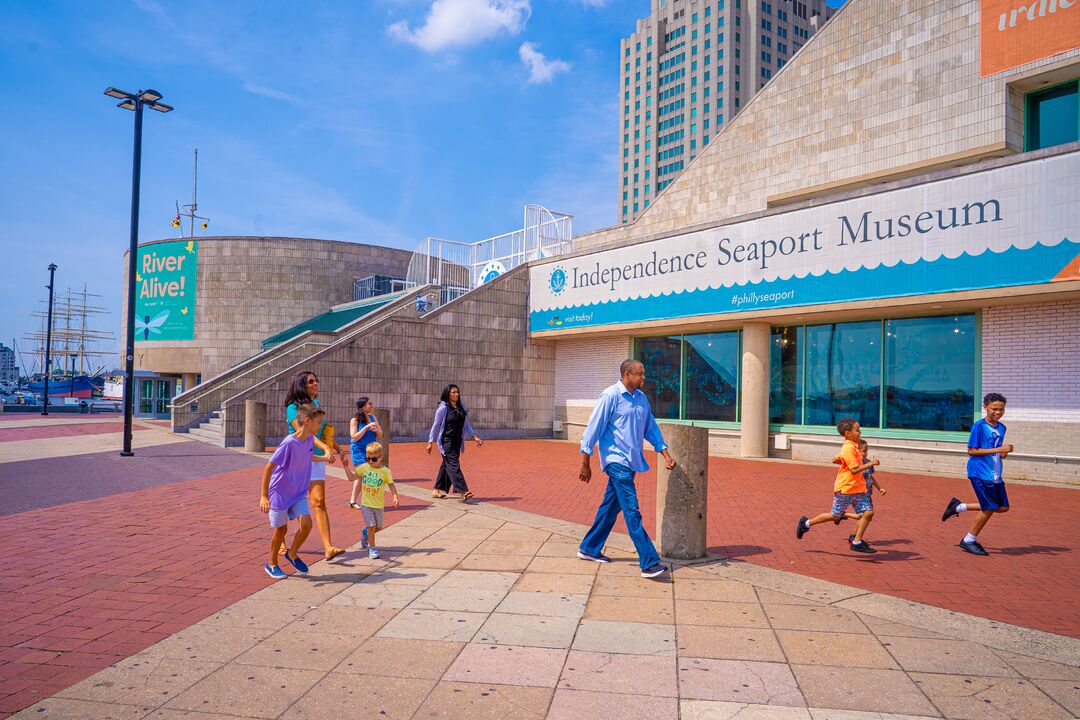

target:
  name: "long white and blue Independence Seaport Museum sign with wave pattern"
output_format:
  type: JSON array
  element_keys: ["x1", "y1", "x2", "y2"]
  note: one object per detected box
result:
[{"x1": 529, "y1": 153, "x2": 1080, "y2": 332}]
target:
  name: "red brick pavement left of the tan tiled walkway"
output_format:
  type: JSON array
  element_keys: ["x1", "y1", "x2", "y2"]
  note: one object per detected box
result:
[{"x1": 0, "y1": 459, "x2": 423, "y2": 718}]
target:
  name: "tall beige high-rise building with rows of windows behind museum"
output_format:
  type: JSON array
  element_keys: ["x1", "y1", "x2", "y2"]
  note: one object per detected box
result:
[{"x1": 618, "y1": 0, "x2": 833, "y2": 223}]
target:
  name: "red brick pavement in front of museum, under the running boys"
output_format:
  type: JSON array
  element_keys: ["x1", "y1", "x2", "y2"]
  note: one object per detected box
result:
[{"x1": 393, "y1": 440, "x2": 1080, "y2": 638}]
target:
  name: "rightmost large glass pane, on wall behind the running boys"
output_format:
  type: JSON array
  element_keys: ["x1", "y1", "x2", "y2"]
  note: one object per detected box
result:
[{"x1": 885, "y1": 315, "x2": 975, "y2": 431}]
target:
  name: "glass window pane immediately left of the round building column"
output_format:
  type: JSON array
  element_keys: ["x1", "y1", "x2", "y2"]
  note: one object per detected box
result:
[{"x1": 683, "y1": 332, "x2": 739, "y2": 422}]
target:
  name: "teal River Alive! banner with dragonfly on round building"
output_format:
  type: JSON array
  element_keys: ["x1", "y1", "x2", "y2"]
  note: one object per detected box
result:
[{"x1": 135, "y1": 240, "x2": 199, "y2": 342}]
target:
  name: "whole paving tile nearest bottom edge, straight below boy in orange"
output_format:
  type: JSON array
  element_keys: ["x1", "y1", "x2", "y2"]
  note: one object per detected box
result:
[{"x1": 792, "y1": 665, "x2": 939, "y2": 717}]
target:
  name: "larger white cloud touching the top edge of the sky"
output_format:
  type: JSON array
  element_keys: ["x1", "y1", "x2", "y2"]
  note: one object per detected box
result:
[{"x1": 387, "y1": 0, "x2": 532, "y2": 53}]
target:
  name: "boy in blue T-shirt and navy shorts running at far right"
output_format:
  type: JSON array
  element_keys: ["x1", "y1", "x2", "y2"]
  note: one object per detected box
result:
[{"x1": 942, "y1": 393, "x2": 1013, "y2": 555}]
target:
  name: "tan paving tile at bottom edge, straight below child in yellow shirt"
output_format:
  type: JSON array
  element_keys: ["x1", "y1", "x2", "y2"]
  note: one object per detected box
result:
[{"x1": 281, "y1": 673, "x2": 435, "y2": 720}]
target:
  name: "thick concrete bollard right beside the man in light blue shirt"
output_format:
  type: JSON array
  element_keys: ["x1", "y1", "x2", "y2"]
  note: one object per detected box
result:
[{"x1": 657, "y1": 423, "x2": 708, "y2": 560}]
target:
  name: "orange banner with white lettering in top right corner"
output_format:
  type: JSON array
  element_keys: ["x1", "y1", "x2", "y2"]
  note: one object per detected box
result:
[{"x1": 980, "y1": 0, "x2": 1080, "y2": 77}]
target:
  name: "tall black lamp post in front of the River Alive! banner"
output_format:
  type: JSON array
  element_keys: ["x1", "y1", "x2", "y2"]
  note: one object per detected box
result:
[{"x1": 105, "y1": 87, "x2": 173, "y2": 458}]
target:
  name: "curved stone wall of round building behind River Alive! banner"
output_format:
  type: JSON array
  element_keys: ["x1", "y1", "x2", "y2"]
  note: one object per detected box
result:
[{"x1": 123, "y1": 237, "x2": 411, "y2": 380}]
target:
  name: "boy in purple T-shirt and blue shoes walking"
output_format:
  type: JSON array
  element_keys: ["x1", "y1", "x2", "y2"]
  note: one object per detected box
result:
[{"x1": 259, "y1": 404, "x2": 328, "y2": 580}]
